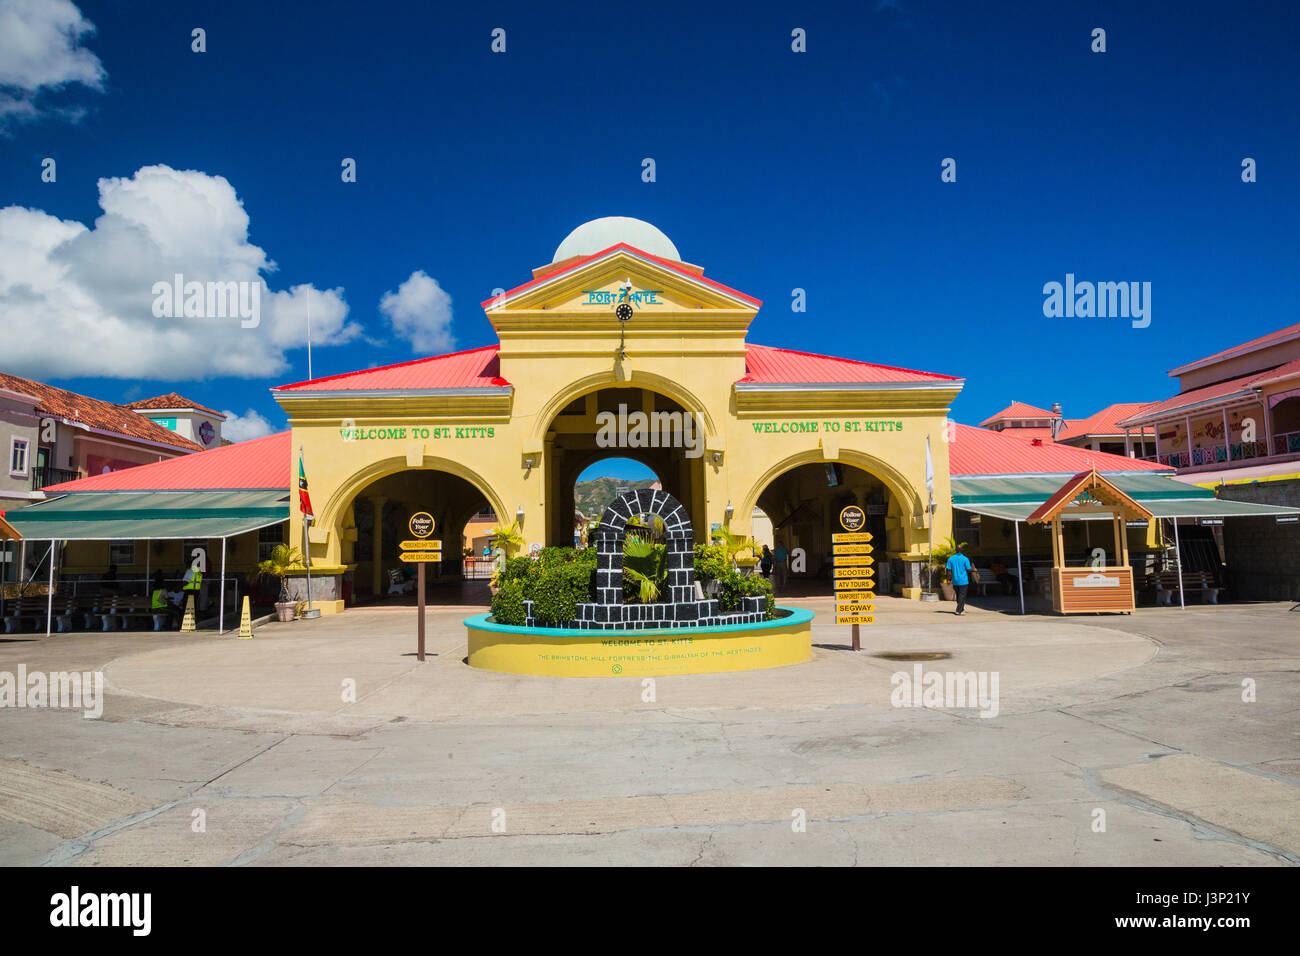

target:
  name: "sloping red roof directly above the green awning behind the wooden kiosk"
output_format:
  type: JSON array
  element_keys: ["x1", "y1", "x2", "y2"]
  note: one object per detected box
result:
[{"x1": 948, "y1": 425, "x2": 1173, "y2": 475}]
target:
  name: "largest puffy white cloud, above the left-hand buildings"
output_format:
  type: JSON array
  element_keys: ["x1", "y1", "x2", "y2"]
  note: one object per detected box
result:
[{"x1": 0, "y1": 165, "x2": 361, "y2": 381}]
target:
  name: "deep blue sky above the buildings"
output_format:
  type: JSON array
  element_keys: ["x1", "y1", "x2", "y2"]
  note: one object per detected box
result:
[{"x1": 0, "y1": 0, "x2": 1300, "y2": 463}]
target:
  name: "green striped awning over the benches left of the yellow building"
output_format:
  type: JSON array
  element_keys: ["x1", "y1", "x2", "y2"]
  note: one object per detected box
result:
[{"x1": 5, "y1": 492, "x2": 289, "y2": 541}]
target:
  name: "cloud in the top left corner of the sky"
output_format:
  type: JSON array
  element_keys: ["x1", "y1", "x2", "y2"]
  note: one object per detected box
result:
[{"x1": 0, "y1": 0, "x2": 107, "y2": 129}]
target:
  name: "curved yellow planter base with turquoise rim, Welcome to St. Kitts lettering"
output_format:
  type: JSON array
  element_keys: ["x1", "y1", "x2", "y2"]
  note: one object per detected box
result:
[{"x1": 465, "y1": 607, "x2": 813, "y2": 678}]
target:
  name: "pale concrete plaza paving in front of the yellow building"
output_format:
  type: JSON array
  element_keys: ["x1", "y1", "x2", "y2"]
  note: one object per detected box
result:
[{"x1": 0, "y1": 598, "x2": 1300, "y2": 866}]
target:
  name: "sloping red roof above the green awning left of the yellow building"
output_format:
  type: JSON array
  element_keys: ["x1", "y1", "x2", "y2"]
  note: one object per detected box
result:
[{"x1": 43, "y1": 432, "x2": 292, "y2": 494}]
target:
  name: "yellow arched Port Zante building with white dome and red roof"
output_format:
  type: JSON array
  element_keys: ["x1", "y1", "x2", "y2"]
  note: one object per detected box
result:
[{"x1": 273, "y1": 217, "x2": 962, "y2": 611}]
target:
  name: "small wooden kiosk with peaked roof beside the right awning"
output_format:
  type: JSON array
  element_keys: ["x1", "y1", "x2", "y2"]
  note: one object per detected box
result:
[{"x1": 1026, "y1": 468, "x2": 1152, "y2": 614}]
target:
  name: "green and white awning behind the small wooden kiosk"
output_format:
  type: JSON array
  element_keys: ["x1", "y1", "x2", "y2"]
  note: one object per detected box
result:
[{"x1": 952, "y1": 472, "x2": 1300, "y2": 522}]
